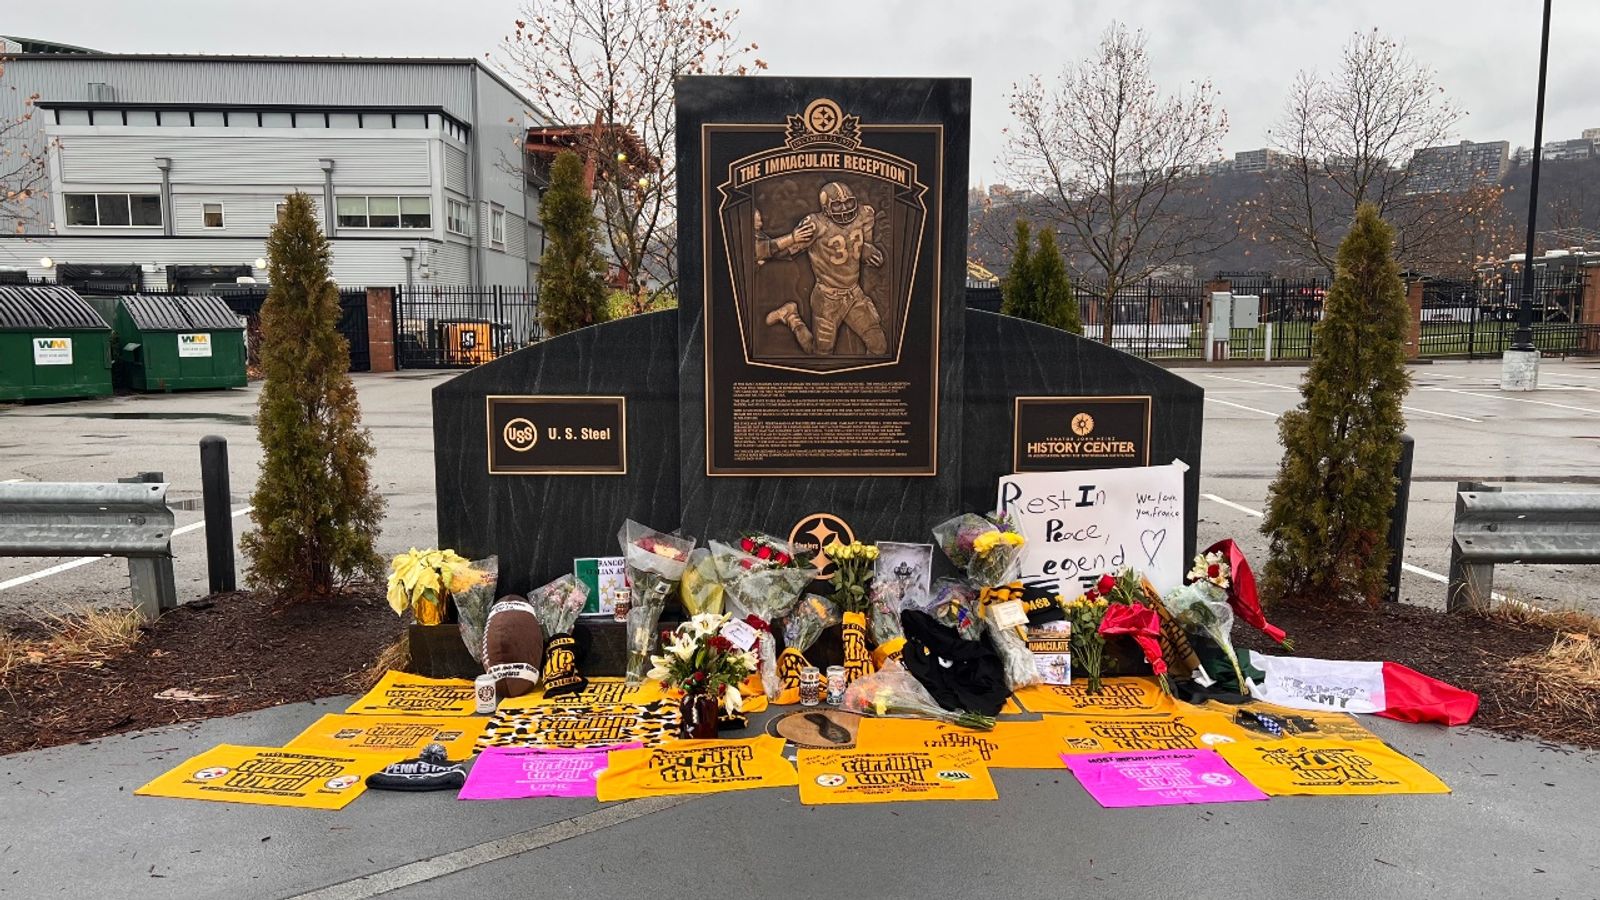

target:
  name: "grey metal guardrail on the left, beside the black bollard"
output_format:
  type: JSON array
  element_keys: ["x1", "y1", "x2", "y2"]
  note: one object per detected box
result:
[{"x1": 0, "y1": 482, "x2": 178, "y2": 618}]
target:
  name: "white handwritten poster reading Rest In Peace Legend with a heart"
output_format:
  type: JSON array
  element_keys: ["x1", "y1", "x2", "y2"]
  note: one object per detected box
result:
[{"x1": 995, "y1": 463, "x2": 1186, "y2": 599}]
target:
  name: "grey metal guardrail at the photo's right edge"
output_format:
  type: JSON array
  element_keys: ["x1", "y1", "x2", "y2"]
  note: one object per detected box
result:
[{"x1": 1445, "y1": 482, "x2": 1600, "y2": 612}]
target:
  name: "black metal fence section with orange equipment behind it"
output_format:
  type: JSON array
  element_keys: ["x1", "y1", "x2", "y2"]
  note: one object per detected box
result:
[{"x1": 395, "y1": 285, "x2": 544, "y2": 361}]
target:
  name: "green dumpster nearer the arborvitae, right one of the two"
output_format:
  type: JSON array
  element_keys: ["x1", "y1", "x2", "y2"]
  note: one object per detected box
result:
[{"x1": 114, "y1": 293, "x2": 245, "y2": 391}]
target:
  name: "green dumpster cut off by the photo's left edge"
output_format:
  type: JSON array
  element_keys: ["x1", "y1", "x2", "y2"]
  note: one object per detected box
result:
[{"x1": 0, "y1": 285, "x2": 112, "y2": 400}]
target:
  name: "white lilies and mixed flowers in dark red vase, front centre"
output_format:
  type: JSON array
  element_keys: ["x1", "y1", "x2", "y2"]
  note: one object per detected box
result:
[{"x1": 648, "y1": 613, "x2": 757, "y2": 738}]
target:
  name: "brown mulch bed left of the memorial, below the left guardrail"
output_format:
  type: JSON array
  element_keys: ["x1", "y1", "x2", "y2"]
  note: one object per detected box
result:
[{"x1": 0, "y1": 586, "x2": 403, "y2": 754}]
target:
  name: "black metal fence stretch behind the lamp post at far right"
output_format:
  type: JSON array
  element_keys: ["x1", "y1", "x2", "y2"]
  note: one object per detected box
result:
[{"x1": 1419, "y1": 269, "x2": 1600, "y2": 359}]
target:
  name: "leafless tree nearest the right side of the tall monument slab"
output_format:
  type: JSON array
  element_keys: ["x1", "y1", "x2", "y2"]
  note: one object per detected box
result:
[{"x1": 1000, "y1": 22, "x2": 1232, "y2": 343}]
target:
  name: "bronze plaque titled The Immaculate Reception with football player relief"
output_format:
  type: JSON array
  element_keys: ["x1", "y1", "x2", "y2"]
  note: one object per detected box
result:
[{"x1": 699, "y1": 96, "x2": 946, "y2": 476}]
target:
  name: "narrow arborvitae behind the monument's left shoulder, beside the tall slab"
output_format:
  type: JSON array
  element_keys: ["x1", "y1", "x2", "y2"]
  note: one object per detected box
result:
[{"x1": 539, "y1": 151, "x2": 610, "y2": 338}]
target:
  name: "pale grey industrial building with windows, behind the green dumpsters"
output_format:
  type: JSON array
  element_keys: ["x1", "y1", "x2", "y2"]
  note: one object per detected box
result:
[{"x1": 0, "y1": 45, "x2": 542, "y2": 288}]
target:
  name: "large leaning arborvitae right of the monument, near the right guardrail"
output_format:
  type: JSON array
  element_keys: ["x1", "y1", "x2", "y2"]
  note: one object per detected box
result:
[{"x1": 1261, "y1": 203, "x2": 1411, "y2": 604}]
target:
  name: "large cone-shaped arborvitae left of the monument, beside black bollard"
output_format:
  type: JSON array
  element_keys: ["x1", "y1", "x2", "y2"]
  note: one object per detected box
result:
[{"x1": 240, "y1": 192, "x2": 384, "y2": 597}]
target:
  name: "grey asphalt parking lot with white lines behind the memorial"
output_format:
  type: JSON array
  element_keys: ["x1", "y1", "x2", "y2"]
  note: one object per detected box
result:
[{"x1": 0, "y1": 360, "x2": 1600, "y2": 613}]
